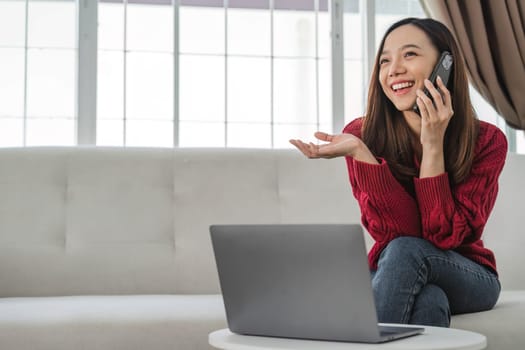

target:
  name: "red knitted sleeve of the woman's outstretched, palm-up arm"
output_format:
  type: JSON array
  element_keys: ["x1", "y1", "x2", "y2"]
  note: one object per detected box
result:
[{"x1": 343, "y1": 119, "x2": 421, "y2": 243}]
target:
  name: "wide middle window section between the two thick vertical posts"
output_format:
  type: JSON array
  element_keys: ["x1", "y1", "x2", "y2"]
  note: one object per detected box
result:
[{"x1": 97, "y1": 0, "x2": 331, "y2": 148}]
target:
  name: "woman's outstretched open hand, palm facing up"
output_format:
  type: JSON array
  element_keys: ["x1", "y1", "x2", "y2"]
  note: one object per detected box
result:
[{"x1": 290, "y1": 131, "x2": 377, "y2": 164}]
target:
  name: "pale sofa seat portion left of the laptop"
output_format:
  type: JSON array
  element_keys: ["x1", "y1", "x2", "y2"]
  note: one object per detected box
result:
[{"x1": 0, "y1": 295, "x2": 226, "y2": 350}]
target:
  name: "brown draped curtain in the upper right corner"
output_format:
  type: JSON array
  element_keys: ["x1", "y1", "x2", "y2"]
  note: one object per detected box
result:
[{"x1": 420, "y1": 0, "x2": 525, "y2": 130}]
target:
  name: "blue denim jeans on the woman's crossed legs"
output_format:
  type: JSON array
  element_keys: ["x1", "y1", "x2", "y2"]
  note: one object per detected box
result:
[{"x1": 372, "y1": 237, "x2": 501, "y2": 327}]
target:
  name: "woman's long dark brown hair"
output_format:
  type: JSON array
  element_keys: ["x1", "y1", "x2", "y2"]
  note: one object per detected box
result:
[{"x1": 362, "y1": 18, "x2": 479, "y2": 192}]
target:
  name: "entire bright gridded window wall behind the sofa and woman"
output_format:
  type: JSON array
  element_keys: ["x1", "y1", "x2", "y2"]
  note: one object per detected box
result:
[{"x1": 0, "y1": 0, "x2": 525, "y2": 152}]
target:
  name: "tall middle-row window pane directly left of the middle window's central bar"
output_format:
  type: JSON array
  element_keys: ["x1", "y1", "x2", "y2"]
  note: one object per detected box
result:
[{"x1": 126, "y1": 52, "x2": 173, "y2": 120}]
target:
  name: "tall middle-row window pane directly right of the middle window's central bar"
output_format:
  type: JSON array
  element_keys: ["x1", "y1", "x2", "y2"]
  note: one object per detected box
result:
[{"x1": 179, "y1": 55, "x2": 225, "y2": 122}]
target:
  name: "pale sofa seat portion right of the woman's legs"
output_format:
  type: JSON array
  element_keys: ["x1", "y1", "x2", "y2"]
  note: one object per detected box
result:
[{"x1": 451, "y1": 291, "x2": 525, "y2": 350}]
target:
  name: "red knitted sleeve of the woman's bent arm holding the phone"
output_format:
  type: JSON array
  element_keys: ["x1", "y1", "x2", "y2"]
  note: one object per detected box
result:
[{"x1": 414, "y1": 123, "x2": 507, "y2": 249}]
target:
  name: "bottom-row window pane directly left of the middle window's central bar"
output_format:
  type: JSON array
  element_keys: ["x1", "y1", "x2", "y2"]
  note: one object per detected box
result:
[{"x1": 126, "y1": 120, "x2": 173, "y2": 147}]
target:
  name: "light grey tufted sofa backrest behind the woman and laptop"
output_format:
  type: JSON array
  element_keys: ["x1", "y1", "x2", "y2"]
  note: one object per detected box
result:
[{"x1": 0, "y1": 147, "x2": 525, "y2": 297}]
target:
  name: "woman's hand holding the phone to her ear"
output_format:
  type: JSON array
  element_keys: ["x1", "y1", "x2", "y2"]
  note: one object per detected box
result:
[{"x1": 416, "y1": 77, "x2": 454, "y2": 149}]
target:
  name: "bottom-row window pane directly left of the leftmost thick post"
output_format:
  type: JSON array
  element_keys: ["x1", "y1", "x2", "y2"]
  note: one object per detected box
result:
[{"x1": 26, "y1": 118, "x2": 75, "y2": 146}]
